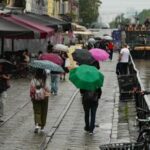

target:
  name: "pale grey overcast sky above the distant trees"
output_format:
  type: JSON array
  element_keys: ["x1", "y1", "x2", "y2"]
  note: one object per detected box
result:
[{"x1": 100, "y1": 0, "x2": 150, "y2": 23}]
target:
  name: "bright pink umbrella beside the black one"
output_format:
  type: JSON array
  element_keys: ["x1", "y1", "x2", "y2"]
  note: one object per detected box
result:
[{"x1": 89, "y1": 48, "x2": 109, "y2": 61}]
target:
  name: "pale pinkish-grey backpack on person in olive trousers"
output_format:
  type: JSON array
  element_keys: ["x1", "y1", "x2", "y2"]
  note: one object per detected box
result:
[{"x1": 34, "y1": 79, "x2": 45, "y2": 100}]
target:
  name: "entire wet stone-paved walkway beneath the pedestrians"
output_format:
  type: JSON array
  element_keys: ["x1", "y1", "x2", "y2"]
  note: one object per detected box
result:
[{"x1": 0, "y1": 53, "x2": 138, "y2": 150}]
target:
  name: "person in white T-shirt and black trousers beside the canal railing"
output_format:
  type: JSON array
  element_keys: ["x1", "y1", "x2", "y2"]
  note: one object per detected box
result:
[{"x1": 119, "y1": 44, "x2": 130, "y2": 75}]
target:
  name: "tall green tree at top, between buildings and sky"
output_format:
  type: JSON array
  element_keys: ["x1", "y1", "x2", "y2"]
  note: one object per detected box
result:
[{"x1": 79, "y1": 0, "x2": 101, "y2": 24}]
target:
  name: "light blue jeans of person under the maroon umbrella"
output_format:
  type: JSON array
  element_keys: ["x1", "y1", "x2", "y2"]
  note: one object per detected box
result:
[{"x1": 51, "y1": 74, "x2": 59, "y2": 94}]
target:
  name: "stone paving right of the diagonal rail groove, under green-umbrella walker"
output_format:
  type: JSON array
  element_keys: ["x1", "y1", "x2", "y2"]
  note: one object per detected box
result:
[{"x1": 47, "y1": 54, "x2": 130, "y2": 150}]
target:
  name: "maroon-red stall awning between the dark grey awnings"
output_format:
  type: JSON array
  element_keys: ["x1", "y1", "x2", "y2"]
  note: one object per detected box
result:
[{"x1": 3, "y1": 15, "x2": 54, "y2": 38}]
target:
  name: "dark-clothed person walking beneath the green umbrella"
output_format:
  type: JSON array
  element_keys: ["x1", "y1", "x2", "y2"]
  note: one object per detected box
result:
[{"x1": 82, "y1": 88, "x2": 102, "y2": 135}]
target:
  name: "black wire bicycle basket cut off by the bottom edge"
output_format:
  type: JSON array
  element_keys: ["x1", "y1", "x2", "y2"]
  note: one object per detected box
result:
[{"x1": 99, "y1": 143, "x2": 144, "y2": 150}]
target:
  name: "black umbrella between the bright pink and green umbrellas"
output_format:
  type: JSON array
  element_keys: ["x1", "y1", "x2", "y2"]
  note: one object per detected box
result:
[{"x1": 72, "y1": 49, "x2": 95, "y2": 65}]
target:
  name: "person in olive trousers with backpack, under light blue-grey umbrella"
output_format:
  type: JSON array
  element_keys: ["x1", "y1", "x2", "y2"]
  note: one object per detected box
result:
[{"x1": 30, "y1": 69, "x2": 50, "y2": 133}]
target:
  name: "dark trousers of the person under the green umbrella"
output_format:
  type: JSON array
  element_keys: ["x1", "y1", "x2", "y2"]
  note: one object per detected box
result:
[{"x1": 83, "y1": 102, "x2": 98, "y2": 132}]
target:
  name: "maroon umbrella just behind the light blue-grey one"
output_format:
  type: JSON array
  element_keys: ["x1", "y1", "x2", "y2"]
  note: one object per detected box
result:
[{"x1": 40, "y1": 53, "x2": 63, "y2": 65}]
